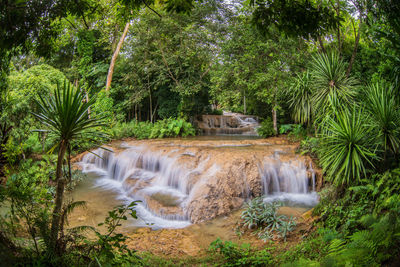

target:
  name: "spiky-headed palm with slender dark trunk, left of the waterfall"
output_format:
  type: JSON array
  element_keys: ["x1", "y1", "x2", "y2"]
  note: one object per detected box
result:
[{"x1": 34, "y1": 82, "x2": 103, "y2": 253}]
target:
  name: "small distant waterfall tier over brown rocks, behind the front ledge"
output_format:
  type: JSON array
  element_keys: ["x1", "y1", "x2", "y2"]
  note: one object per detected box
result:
[{"x1": 197, "y1": 113, "x2": 260, "y2": 136}]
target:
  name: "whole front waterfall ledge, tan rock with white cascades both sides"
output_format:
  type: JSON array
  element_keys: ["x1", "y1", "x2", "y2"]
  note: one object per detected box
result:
[{"x1": 79, "y1": 139, "x2": 316, "y2": 228}]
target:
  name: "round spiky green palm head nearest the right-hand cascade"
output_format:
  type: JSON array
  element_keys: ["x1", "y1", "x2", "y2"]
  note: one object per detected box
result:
[{"x1": 318, "y1": 109, "x2": 377, "y2": 185}]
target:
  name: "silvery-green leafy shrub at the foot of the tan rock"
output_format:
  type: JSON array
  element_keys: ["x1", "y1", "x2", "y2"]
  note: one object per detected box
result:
[{"x1": 241, "y1": 198, "x2": 296, "y2": 241}]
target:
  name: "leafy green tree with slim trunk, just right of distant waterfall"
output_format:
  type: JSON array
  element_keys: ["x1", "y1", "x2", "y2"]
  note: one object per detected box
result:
[{"x1": 211, "y1": 12, "x2": 307, "y2": 131}]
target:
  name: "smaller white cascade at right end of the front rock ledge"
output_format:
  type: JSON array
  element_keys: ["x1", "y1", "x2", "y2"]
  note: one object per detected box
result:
[{"x1": 260, "y1": 159, "x2": 318, "y2": 206}]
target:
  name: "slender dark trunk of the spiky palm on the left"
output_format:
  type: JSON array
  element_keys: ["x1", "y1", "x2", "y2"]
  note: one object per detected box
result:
[{"x1": 50, "y1": 140, "x2": 67, "y2": 253}]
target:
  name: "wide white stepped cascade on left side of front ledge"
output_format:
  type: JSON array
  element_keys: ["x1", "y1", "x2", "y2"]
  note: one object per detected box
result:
[{"x1": 81, "y1": 147, "x2": 201, "y2": 228}]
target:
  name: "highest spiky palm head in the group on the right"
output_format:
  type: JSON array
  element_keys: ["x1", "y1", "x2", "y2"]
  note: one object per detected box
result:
[{"x1": 311, "y1": 53, "x2": 357, "y2": 119}]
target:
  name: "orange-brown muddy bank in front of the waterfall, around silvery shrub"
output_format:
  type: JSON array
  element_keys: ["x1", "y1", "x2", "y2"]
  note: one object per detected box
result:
[{"x1": 127, "y1": 207, "x2": 310, "y2": 258}]
